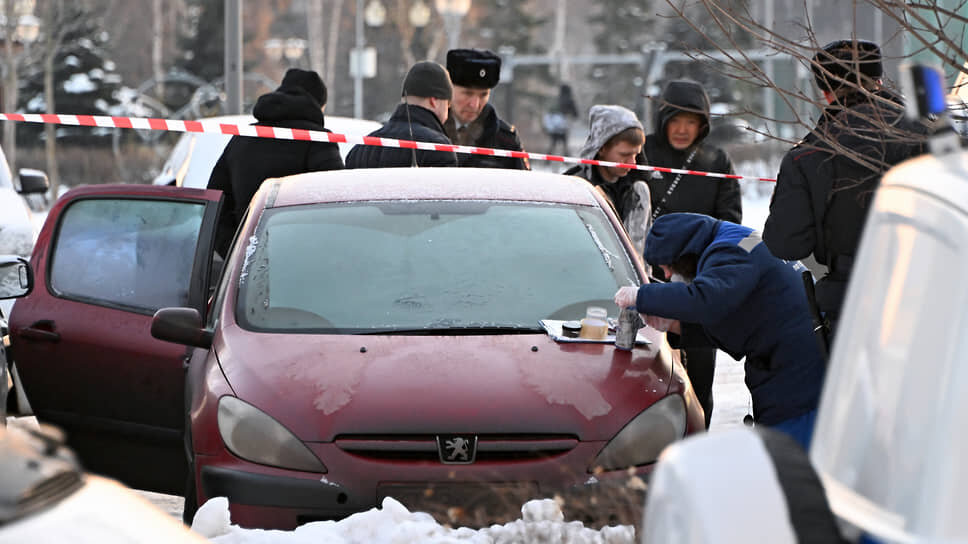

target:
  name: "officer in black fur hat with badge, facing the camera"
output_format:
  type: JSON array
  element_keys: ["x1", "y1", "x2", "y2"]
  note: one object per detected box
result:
[{"x1": 444, "y1": 49, "x2": 530, "y2": 170}]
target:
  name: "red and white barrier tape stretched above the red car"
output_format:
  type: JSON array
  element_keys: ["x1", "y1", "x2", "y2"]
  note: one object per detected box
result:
[{"x1": 0, "y1": 113, "x2": 776, "y2": 182}]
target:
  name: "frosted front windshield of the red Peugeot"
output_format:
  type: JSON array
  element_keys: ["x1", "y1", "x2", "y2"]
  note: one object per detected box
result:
[{"x1": 236, "y1": 201, "x2": 639, "y2": 334}]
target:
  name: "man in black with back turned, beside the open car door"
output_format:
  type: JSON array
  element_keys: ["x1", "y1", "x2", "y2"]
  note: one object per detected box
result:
[{"x1": 208, "y1": 68, "x2": 343, "y2": 256}]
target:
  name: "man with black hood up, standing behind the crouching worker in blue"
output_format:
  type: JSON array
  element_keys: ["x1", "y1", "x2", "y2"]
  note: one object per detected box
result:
[{"x1": 633, "y1": 80, "x2": 743, "y2": 428}]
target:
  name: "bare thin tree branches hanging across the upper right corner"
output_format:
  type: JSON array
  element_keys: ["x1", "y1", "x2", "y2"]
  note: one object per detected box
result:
[{"x1": 666, "y1": 0, "x2": 948, "y2": 169}]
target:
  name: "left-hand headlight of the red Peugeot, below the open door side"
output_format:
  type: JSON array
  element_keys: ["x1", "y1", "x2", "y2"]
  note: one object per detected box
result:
[{"x1": 218, "y1": 396, "x2": 326, "y2": 472}]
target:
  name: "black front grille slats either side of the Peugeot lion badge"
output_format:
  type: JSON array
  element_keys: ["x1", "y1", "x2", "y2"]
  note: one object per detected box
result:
[{"x1": 334, "y1": 433, "x2": 578, "y2": 463}]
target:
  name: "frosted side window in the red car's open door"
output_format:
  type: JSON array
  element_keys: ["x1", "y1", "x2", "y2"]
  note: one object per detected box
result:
[{"x1": 49, "y1": 198, "x2": 205, "y2": 314}]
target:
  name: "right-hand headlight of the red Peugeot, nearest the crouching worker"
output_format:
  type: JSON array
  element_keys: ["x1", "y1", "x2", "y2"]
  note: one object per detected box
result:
[{"x1": 589, "y1": 395, "x2": 686, "y2": 472}]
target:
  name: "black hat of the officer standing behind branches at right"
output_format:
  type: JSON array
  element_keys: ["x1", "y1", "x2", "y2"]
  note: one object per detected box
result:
[{"x1": 810, "y1": 40, "x2": 884, "y2": 92}]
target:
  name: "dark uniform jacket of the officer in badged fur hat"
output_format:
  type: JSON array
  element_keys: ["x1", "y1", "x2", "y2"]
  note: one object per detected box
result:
[{"x1": 444, "y1": 104, "x2": 530, "y2": 170}]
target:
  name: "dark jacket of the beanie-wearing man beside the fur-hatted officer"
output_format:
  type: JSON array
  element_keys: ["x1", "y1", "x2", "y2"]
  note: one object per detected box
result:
[{"x1": 346, "y1": 104, "x2": 457, "y2": 168}]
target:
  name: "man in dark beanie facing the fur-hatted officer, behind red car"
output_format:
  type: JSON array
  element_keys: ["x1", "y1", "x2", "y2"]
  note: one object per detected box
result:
[{"x1": 346, "y1": 61, "x2": 457, "y2": 168}]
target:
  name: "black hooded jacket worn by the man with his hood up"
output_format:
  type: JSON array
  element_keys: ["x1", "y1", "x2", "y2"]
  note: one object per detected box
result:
[{"x1": 635, "y1": 81, "x2": 743, "y2": 223}]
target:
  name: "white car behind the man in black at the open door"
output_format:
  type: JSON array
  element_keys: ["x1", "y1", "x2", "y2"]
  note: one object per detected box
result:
[{"x1": 152, "y1": 115, "x2": 381, "y2": 189}]
